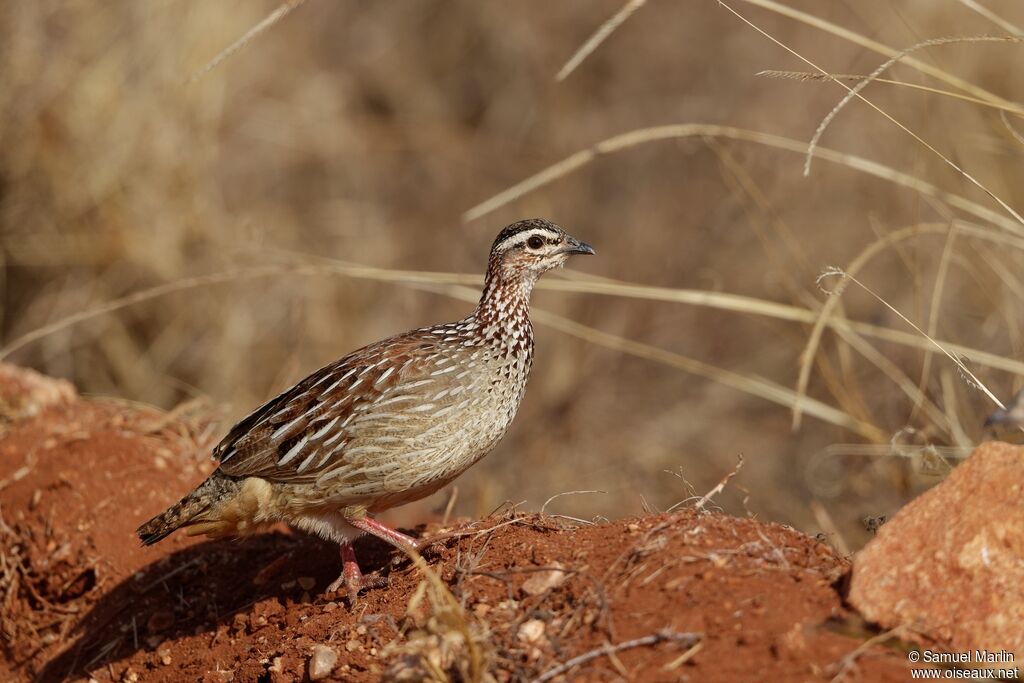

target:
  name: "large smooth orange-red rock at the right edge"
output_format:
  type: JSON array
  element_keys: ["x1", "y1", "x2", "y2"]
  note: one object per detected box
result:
[{"x1": 849, "y1": 442, "x2": 1024, "y2": 661}]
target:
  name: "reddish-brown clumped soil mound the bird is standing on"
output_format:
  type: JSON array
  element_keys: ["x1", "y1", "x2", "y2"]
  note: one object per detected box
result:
[{"x1": 0, "y1": 371, "x2": 908, "y2": 683}]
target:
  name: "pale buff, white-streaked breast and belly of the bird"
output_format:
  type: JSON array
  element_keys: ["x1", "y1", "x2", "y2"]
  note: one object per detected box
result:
[{"x1": 317, "y1": 330, "x2": 532, "y2": 512}]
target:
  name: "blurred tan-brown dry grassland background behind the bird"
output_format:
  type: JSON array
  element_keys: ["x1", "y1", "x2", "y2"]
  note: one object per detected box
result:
[{"x1": 0, "y1": 0, "x2": 1024, "y2": 545}]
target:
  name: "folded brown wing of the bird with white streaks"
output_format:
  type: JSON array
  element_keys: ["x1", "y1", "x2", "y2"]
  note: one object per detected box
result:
[{"x1": 213, "y1": 330, "x2": 441, "y2": 483}]
